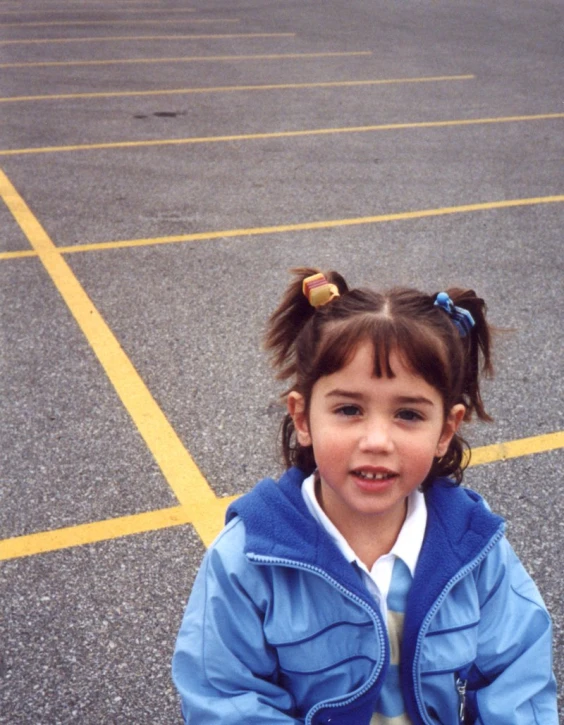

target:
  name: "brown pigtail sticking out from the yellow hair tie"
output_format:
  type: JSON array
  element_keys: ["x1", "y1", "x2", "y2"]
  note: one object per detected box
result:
[{"x1": 265, "y1": 267, "x2": 348, "y2": 380}]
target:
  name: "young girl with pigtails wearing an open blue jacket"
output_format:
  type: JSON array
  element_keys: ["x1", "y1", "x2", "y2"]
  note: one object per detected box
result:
[{"x1": 173, "y1": 269, "x2": 558, "y2": 725}]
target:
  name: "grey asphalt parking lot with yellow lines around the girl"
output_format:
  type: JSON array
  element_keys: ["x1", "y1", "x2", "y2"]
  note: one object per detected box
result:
[{"x1": 0, "y1": 0, "x2": 564, "y2": 725}]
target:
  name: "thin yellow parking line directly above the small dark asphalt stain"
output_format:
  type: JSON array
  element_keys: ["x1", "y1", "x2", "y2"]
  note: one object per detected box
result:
[{"x1": 0, "y1": 75, "x2": 474, "y2": 103}]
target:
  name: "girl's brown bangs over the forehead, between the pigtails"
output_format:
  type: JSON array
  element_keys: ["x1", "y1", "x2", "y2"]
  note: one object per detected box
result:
[{"x1": 310, "y1": 312, "x2": 454, "y2": 406}]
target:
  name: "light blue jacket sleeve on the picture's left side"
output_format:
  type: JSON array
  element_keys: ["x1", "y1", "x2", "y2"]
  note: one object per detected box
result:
[{"x1": 172, "y1": 520, "x2": 303, "y2": 725}]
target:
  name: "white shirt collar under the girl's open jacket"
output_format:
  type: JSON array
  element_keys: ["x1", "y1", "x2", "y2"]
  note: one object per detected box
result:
[{"x1": 302, "y1": 473, "x2": 427, "y2": 622}]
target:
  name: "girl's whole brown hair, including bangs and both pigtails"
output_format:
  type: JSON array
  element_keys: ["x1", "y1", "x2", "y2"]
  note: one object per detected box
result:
[{"x1": 265, "y1": 268, "x2": 493, "y2": 488}]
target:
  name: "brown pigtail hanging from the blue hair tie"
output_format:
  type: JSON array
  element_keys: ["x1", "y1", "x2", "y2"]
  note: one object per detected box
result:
[{"x1": 447, "y1": 288, "x2": 493, "y2": 421}]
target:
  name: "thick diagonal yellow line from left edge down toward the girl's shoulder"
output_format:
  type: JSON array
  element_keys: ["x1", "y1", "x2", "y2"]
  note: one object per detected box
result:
[{"x1": 0, "y1": 170, "x2": 215, "y2": 534}]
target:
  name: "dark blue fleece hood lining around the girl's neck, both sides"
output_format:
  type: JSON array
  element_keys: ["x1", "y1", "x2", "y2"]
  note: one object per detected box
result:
[{"x1": 226, "y1": 468, "x2": 503, "y2": 604}]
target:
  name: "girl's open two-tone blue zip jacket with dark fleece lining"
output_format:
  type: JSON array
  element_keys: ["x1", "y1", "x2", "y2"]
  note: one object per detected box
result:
[{"x1": 173, "y1": 469, "x2": 558, "y2": 725}]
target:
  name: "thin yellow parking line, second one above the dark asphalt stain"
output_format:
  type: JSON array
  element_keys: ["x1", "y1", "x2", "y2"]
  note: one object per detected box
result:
[{"x1": 0, "y1": 50, "x2": 372, "y2": 68}]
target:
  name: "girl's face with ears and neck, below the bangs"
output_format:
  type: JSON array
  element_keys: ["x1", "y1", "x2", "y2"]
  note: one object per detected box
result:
[{"x1": 288, "y1": 343, "x2": 464, "y2": 536}]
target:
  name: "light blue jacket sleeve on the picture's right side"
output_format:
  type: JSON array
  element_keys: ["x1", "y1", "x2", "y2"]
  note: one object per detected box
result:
[{"x1": 469, "y1": 538, "x2": 558, "y2": 725}]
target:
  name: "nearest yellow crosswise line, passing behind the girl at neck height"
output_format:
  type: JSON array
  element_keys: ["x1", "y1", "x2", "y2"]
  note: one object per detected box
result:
[{"x1": 0, "y1": 431, "x2": 564, "y2": 561}]
